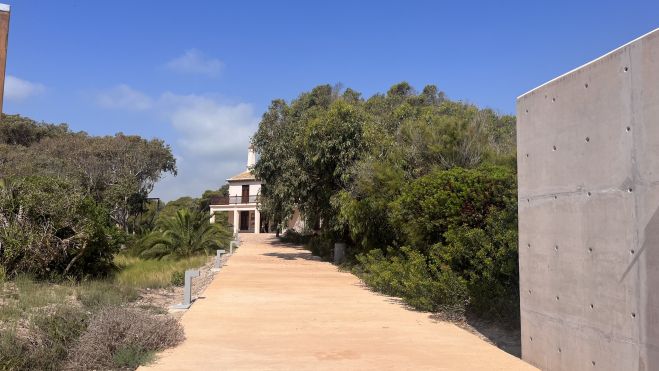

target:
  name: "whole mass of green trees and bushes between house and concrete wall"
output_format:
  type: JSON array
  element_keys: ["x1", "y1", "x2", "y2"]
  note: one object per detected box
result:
[{"x1": 253, "y1": 82, "x2": 518, "y2": 322}]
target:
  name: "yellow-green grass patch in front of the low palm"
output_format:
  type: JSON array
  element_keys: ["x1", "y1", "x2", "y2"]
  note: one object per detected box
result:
[{"x1": 115, "y1": 255, "x2": 210, "y2": 289}]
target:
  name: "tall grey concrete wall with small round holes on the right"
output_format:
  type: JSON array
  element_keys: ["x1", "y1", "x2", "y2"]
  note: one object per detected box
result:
[{"x1": 517, "y1": 30, "x2": 659, "y2": 370}]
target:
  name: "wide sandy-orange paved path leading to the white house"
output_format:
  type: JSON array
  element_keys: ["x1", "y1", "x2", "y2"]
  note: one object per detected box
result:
[{"x1": 142, "y1": 235, "x2": 533, "y2": 370}]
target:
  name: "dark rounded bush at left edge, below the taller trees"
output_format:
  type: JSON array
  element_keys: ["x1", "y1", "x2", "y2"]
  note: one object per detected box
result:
[{"x1": 0, "y1": 176, "x2": 123, "y2": 278}]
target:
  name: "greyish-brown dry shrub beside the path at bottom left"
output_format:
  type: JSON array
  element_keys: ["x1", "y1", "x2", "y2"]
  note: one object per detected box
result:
[{"x1": 70, "y1": 308, "x2": 183, "y2": 369}]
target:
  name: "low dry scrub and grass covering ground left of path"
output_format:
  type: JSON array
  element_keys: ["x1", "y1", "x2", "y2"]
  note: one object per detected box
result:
[{"x1": 0, "y1": 255, "x2": 218, "y2": 370}]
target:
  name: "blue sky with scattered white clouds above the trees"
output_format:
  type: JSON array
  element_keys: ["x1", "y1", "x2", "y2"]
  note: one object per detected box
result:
[{"x1": 4, "y1": 0, "x2": 659, "y2": 200}]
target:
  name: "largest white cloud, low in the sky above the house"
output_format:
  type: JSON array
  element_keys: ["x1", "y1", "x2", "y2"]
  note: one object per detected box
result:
[{"x1": 152, "y1": 93, "x2": 259, "y2": 200}]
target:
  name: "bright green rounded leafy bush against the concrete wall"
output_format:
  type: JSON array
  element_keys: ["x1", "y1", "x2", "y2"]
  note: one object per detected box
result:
[{"x1": 392, "y1": 166, "x2": 519, "y2": 318}]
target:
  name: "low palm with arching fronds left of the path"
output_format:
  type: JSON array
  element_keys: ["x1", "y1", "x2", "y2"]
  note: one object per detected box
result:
[{"x1": 140, "y1": 209, "x2": 232, "y2": 259}]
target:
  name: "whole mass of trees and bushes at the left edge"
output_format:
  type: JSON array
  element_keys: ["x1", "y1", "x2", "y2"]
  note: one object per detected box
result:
[{"x1": 0, "y1": 115, "x2": 176, "y2": 278}]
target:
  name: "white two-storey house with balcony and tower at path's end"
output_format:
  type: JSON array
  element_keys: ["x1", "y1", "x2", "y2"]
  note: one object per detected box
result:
[{"x1": 210, "y1": 145, "x2": 261, "y2": 233}]
